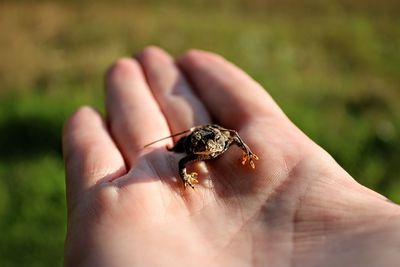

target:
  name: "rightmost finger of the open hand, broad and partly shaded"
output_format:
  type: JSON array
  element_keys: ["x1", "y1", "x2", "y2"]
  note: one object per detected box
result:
[{"x1": 179, "y1": 50, "x2": 285, "y2": 128}]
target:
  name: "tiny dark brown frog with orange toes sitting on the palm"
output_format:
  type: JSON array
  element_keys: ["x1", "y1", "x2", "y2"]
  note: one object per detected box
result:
[{"x1": 149, "y1": 124, "x2": 258, "y2": 189}]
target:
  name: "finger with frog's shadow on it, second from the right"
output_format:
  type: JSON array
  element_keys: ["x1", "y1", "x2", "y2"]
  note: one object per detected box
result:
[{"x1": 138, "y1": 47, "x2": 211, "y2": 138}]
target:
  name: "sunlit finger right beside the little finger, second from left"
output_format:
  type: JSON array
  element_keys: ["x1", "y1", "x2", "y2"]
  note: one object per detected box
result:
[{"x1": 106, "y1": 59, "x2": 170, "y2": 166}]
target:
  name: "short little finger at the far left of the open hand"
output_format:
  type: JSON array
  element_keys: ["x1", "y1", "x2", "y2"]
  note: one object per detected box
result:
[{"x1": 63, "y1": 107, "x2": 126, "y2": 209}]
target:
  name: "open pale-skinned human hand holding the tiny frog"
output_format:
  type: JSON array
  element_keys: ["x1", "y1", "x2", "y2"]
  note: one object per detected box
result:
[{"x1": 63, "y1": 47, "x2": 400, "y2": 267}]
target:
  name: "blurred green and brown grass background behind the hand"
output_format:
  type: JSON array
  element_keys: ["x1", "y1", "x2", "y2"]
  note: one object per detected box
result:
[{"x1": 0, "y1": 0, "x2": 400, "y2": 267}]
